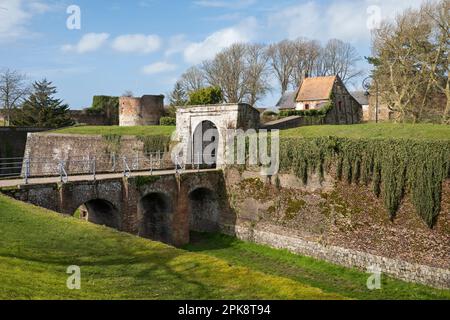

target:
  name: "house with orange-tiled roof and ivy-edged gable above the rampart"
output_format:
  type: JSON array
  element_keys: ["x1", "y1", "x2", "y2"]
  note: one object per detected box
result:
[{"x1": 279, "y1": 76, "x2": 363, "y2": 124}]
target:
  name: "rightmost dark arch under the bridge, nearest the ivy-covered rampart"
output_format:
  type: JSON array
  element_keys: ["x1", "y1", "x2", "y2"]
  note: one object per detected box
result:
[{"x1": 189, "y1": 188, "x2": 220, "y2": 232}]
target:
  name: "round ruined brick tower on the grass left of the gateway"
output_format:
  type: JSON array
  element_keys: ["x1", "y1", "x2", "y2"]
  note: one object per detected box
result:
[{"x1": 119, "y1": 95, "x2": 164, "y2": 126}]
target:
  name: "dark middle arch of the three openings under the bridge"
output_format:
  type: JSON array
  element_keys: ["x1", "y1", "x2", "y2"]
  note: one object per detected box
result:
[{"x1": 138, "y1": 192, "x2": 173, "y2": 243}]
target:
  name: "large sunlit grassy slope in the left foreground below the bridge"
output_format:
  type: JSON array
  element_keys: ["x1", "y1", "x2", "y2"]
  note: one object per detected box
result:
[{"x1": 0, "y1": 195, "x2": 343, "y2": 299}]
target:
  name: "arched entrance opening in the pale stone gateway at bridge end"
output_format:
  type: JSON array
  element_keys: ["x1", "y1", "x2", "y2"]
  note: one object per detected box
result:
[{"x1": 192, "y1": 121, "x2": 219, "y2": 167}]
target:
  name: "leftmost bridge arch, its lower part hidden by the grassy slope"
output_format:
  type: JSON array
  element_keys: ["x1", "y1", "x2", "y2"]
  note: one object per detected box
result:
[{"x1": 74, "y1": 199, "x2": 121, "y2": 230}]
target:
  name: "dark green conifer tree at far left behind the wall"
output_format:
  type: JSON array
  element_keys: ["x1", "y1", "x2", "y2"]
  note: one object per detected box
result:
[{"x1": 14, "y1": 79, "x2": 73, "y2": 128}]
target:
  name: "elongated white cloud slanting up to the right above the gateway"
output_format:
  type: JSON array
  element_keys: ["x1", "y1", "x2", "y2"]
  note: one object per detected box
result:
[{"x1": 184, "y1": 17, "x2": 258, "y2": 63}]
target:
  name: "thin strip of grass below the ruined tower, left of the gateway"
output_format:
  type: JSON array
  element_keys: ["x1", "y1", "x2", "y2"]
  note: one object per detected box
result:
[{"x1": 48, "y1": 126, "x2": 175, "y2": 136}]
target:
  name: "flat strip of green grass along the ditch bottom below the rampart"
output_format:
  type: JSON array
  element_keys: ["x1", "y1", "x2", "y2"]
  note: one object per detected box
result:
[{"x1": 185, "y1": 233, "x2": 450, "y2": 300}]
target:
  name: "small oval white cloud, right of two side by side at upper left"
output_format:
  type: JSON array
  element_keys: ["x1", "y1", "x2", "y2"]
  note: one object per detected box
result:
[{"x1": 112, "y1": 34, "x2": 161, "y2": 53}]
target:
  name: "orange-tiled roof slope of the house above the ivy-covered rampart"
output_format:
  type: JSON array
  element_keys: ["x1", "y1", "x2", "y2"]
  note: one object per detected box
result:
[{"x1": 296, "y1": 76, "x2": 336, "y2": 102}]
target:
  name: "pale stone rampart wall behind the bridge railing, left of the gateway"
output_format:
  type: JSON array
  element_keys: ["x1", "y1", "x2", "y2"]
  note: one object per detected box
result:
[{"x1": 21, "y1": 133, "x2": 172, "y2": 176}]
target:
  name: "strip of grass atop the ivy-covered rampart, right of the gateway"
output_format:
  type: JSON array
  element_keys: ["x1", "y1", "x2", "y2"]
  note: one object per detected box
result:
[{"x1": 281, "y1": 123, "x2": 450, "y2": 140}]
